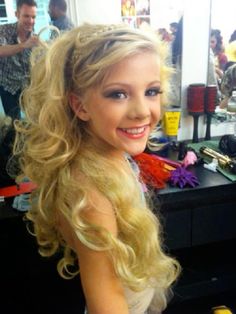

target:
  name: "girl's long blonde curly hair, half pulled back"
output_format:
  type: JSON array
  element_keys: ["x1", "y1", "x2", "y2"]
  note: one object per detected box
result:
[{"x1": 15, "y1": 24, "x2": 180, "y2": 309}]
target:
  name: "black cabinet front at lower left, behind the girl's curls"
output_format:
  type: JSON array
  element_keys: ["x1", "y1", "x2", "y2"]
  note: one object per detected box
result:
[{"x1": 0, "y1": 203, "x2": 85, "y2": 314}]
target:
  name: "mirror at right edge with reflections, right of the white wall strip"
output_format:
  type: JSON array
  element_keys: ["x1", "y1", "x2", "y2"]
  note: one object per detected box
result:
[{"x1": 208, "y1": 0, "x2": 236, "y2": 123}]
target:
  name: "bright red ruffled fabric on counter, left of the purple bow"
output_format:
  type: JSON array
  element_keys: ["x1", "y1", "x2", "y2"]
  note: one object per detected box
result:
[{"x1": 132, "y1": 153, "x2": 170, "y2": 189}]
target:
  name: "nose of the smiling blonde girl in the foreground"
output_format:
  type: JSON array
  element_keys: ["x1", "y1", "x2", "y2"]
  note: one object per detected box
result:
[{"x1": 128, "y1": 95, "x2": 150, "y2": 120}]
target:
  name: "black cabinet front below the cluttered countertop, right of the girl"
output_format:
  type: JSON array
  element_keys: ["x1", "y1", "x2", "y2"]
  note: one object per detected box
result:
[{"x1": 158, "y1": 167, "x2": 236, "y2": 306}]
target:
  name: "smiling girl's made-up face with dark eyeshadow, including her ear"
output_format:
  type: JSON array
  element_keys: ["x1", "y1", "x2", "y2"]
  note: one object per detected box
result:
[{"x1": 75, "y1": 52, "x2": 161, "y2": 155}]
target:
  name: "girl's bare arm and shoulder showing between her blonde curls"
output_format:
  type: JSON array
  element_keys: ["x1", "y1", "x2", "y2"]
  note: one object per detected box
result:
[{"x1": 60, "y1": 188, "x2": 129, "y2": 314}]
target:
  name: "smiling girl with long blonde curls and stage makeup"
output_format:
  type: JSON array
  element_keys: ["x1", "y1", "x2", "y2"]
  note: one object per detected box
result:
[{"x1": 14, "y1": 24, "x2": 180, "y2": 314}]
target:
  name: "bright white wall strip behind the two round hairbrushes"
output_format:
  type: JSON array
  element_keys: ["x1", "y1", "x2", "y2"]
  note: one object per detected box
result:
[{"x1": 178, "y1": 0, "x2": 210, "y2": 140}]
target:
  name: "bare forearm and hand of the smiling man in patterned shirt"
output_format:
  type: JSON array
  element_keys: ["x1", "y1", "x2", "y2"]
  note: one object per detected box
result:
[{"x1": 0, "y1": 36, "x2": 39, "y2": 57}]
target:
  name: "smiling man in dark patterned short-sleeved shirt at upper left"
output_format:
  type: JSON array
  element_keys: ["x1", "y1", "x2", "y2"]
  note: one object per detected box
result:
[{"x1": 0, "y1": 0, "x2": 39, "y2": 120}]
